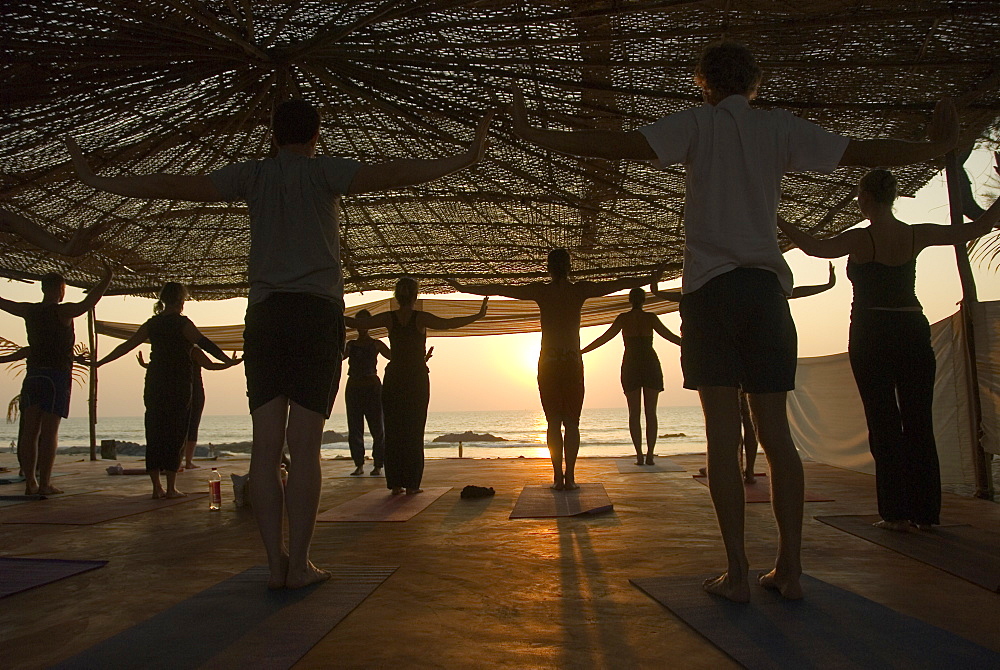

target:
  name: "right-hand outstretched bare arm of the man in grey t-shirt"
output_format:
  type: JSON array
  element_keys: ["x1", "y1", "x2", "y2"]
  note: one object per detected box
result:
[{"x1": 347, "y1": 112, "x2": 493, "y2": 195}]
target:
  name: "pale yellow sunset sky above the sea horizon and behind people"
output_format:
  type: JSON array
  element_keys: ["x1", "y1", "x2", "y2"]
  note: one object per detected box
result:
[{"x1": 0, "y1": 151, "x2": 1000, "y2": 417}]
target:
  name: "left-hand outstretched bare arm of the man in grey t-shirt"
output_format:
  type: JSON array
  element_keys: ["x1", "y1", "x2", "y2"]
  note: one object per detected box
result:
[{"x1": 66, "y1": 137, "x2": 222, "y2": 202}]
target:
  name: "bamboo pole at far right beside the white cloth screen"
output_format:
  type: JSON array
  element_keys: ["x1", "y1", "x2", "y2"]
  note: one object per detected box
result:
[{"x1": 945, "y1": 151, "x2": 993, "y2": 500}]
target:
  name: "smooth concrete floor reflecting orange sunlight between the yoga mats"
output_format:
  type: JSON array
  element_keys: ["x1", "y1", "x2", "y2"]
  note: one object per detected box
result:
[{"x1": 0, "y1": 454, "x2": 1000, "y2": 668}]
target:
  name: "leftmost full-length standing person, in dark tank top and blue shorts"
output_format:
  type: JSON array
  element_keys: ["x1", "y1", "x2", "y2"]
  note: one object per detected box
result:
[{"x1": 0, "y1": 264, "x2": 113, "y2": 495}]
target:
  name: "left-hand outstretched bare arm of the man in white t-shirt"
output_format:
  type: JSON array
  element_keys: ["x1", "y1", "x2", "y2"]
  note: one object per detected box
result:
[{"x1": 511, "y1": 89, "x2": 656, "y2": 160}]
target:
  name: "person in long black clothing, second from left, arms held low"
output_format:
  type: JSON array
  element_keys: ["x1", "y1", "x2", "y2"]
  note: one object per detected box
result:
[{"x1": 97, "y1": 282, "x2": 238, "y2": 498}]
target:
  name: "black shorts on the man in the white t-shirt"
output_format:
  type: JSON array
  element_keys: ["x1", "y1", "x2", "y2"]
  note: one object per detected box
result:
[{"x1": 680, "y1": 268, "x2": 798, "y2": 393}]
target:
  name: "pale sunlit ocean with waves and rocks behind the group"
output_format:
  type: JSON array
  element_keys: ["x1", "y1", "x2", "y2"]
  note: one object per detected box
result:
[{"x1": 0, "y1": 407, "x2": 705, "y2": 458}]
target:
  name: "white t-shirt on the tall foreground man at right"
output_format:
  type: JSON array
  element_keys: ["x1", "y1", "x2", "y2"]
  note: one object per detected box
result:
[{"x1": 639, "y1": 95, "x2": 850, "y2": 294}]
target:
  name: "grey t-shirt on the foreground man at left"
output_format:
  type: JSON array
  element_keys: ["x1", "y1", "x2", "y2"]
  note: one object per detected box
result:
[{"x1": 208, "y1": 150, "x2": 361, "y2": 309}]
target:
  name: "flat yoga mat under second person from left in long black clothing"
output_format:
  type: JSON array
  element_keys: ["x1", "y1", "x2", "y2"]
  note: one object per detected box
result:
[{"x1": 0, "y1": 493, "x2": 208, "y2": 526}]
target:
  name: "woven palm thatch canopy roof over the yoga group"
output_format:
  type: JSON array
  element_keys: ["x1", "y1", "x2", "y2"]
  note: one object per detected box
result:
[{"x1": 0, "y1": 0, "x2": 1000, "y2": 298}]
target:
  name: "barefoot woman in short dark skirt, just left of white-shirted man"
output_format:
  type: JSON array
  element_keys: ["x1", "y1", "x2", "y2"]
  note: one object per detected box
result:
[{"x1": 580, "y1": 288, "x2": 681, "y2": 465}]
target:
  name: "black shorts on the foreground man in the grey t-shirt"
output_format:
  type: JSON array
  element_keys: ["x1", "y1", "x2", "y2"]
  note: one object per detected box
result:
[{"x1": 243, "y1": 293, "x2": 345, "y2": 418}]
